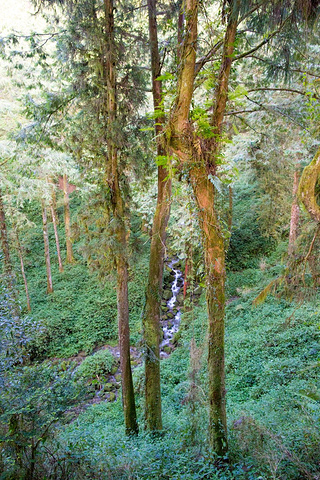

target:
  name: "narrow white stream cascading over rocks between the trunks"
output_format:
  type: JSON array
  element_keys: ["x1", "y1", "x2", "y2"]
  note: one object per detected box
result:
[{"x1": 160, "y1": 260, "x2": 183, "y2": 358}]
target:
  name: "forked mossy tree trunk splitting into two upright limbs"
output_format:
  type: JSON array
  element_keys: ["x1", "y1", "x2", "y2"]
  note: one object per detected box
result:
[{"x1": 168, "y1": 0, "x2": 238, "y2": 455}]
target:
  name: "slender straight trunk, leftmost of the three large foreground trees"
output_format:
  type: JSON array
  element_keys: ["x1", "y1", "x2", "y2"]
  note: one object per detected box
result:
[{"x1": 104, "y1": 0, "x2": 138, "y2": 434}]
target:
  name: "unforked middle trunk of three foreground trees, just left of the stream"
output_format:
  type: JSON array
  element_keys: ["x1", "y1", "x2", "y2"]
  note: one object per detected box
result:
[{"x1": 143, "y1": 0, "x2": 171, "y2": 431}]
